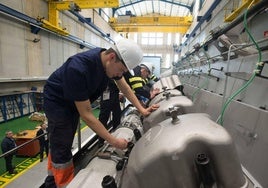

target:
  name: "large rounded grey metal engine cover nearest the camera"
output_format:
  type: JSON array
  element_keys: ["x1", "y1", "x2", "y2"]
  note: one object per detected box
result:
[{"x1": 121, "y1": 114, "x2": 247, "y2": 188}]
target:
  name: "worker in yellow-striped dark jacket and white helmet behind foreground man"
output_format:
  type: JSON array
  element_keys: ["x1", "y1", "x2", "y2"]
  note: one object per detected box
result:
[{"x1": 124, "y1": 62, "x2": 160, "y2": 107}]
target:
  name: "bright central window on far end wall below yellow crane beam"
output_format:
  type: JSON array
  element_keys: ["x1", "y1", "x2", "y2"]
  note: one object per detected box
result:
[{"x1": 141, "y1": 33, "x2": 164, "y2": 45}]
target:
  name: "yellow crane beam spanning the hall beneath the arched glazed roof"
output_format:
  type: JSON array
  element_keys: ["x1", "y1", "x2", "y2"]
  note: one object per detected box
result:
[{"x1": 109, "y1": 15, "x2": 193, "y2": 34}]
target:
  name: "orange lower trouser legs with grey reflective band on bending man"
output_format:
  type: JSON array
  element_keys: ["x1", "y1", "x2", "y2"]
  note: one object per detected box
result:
[{"x1": 47, "y1": 154, "x2": 74, "y2": 188}]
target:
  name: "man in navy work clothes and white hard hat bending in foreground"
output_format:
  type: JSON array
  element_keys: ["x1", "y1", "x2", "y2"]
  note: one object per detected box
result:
[{"x1": 41, "y1": 39, "x2": 159, "y2": 187}]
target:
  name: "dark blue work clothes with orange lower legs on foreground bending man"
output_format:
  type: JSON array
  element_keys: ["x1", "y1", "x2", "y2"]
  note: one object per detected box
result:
[{"x1": 44, "y1": 48, "x2": 109, "y2": 187}]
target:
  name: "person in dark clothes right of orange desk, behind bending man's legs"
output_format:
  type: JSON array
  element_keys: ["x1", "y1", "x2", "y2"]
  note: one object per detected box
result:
[{"x1": 36, "y1": 123, "x2": 48, "y2": 162}]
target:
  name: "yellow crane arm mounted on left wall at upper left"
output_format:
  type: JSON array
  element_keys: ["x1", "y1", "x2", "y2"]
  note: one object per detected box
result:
[{"x1": 38, "y1": 0, "x2": 119, "y2": 35}]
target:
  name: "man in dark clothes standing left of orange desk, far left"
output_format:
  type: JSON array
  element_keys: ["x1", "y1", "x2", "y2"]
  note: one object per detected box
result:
[{"x1": 1, "y1": 131, "x2": 17, "y2": 174}]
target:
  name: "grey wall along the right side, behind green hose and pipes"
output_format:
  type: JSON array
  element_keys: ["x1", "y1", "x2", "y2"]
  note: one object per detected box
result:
[{"x1": 173, "y1": 1, "x2": 268, "y2": 187}]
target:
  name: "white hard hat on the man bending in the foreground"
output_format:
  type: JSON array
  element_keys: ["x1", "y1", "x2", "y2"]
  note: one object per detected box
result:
[{"x1": 113, "y1": 39, "x2": 143, "y2": 71}]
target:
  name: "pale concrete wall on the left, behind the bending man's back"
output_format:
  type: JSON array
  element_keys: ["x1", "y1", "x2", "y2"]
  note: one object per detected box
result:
[{"x1": 0, "y1": 0, "x2": 118, "y2": 93}]
